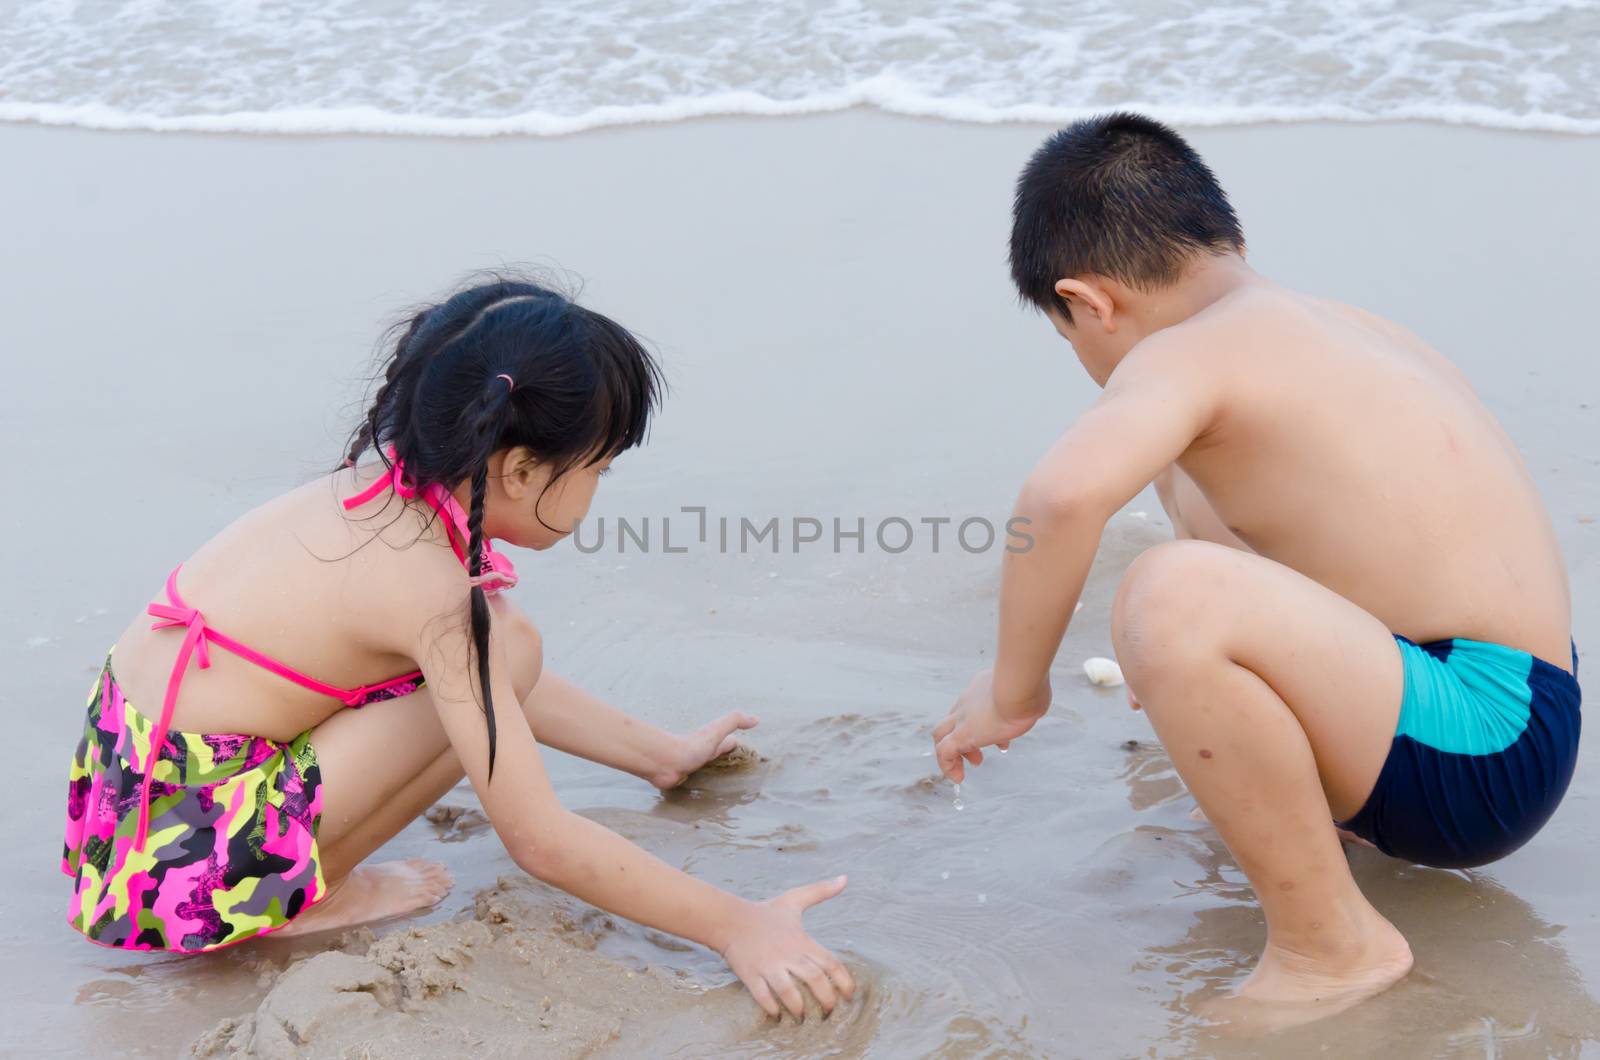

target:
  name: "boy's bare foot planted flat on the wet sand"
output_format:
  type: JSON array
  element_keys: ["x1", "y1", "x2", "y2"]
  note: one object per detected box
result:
[{"x1": 1202, "y1": 914, "x2": 1411, "y2": 1034}]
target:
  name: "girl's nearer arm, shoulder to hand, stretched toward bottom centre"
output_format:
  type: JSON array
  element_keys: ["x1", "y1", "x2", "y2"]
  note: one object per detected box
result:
[{"x1": 414, "y1": 592, "x2": 854, "y2": 1018}]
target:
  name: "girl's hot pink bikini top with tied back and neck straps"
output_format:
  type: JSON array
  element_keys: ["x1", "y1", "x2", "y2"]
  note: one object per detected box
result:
[{"x1": 133, "y1": 448, "x2": 517, "y2": 850}]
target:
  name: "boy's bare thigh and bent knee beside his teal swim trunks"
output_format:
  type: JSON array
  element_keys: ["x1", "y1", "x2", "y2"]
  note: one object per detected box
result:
[{"x1": 1114, "y1": 541, "x2": 1405, "y2": 818}]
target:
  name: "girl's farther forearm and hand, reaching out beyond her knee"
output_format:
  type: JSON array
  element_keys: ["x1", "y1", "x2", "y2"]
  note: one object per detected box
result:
[{"x1": 523, "y1": 671, "x2": 757, "y2": 791}]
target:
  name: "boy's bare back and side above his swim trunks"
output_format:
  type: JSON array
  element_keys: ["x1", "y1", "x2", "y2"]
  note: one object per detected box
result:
[{"x1": 1130, "y1": 285, "x2": 1571, "y2": 669}]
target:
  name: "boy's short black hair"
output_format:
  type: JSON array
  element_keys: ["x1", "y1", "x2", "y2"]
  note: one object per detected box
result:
[{"x1": 1011, "y1": 110, "x2": 1245, "y2": 320}]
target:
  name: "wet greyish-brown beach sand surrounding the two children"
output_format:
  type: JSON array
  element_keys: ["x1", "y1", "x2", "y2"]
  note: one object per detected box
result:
[{"x1": 0, "y1": 114, "x2": 1600, "y2": 1057}]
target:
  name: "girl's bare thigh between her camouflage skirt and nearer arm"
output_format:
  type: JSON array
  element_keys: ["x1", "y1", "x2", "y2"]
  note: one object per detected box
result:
[{"x1": 310, "y1": 687, "x2": 450, "y2": 847}]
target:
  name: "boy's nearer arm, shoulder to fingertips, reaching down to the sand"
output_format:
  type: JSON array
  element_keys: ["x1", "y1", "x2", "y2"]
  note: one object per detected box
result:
[{"x1": 934, "y1": 333, "x2": 1218, "y2": 781}]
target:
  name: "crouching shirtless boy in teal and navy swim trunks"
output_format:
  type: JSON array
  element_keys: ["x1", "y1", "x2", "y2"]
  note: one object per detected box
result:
[{"x1": 934, "y1": 114, "x2": 1579, "y2": 1022}]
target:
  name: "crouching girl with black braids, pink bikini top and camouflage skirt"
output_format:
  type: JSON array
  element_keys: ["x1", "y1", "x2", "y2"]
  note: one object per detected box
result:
[{"x1": 62, "y1": 280, "x2": 854, "y2": 1018}]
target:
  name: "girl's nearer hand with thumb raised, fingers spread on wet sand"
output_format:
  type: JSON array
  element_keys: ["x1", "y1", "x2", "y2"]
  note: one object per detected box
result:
[{"x1": 722, "y1": 876, "x2": 856, "y2": 1020}]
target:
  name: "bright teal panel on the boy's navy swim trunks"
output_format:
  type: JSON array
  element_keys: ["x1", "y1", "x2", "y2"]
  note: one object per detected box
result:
[{"x1": 1395, "y1": 639, "x2": 1533, "y2": 754}]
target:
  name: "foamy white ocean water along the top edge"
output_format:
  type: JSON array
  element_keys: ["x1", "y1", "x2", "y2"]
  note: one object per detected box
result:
[{"x1": 0, "y1": 0, "x2": 1600, "y2": 136}]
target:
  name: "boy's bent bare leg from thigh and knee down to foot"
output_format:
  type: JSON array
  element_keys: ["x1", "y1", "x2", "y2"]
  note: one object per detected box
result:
[{"x1": 1112, "y1": 541, "x2": 1411, "y2": 1022}]
